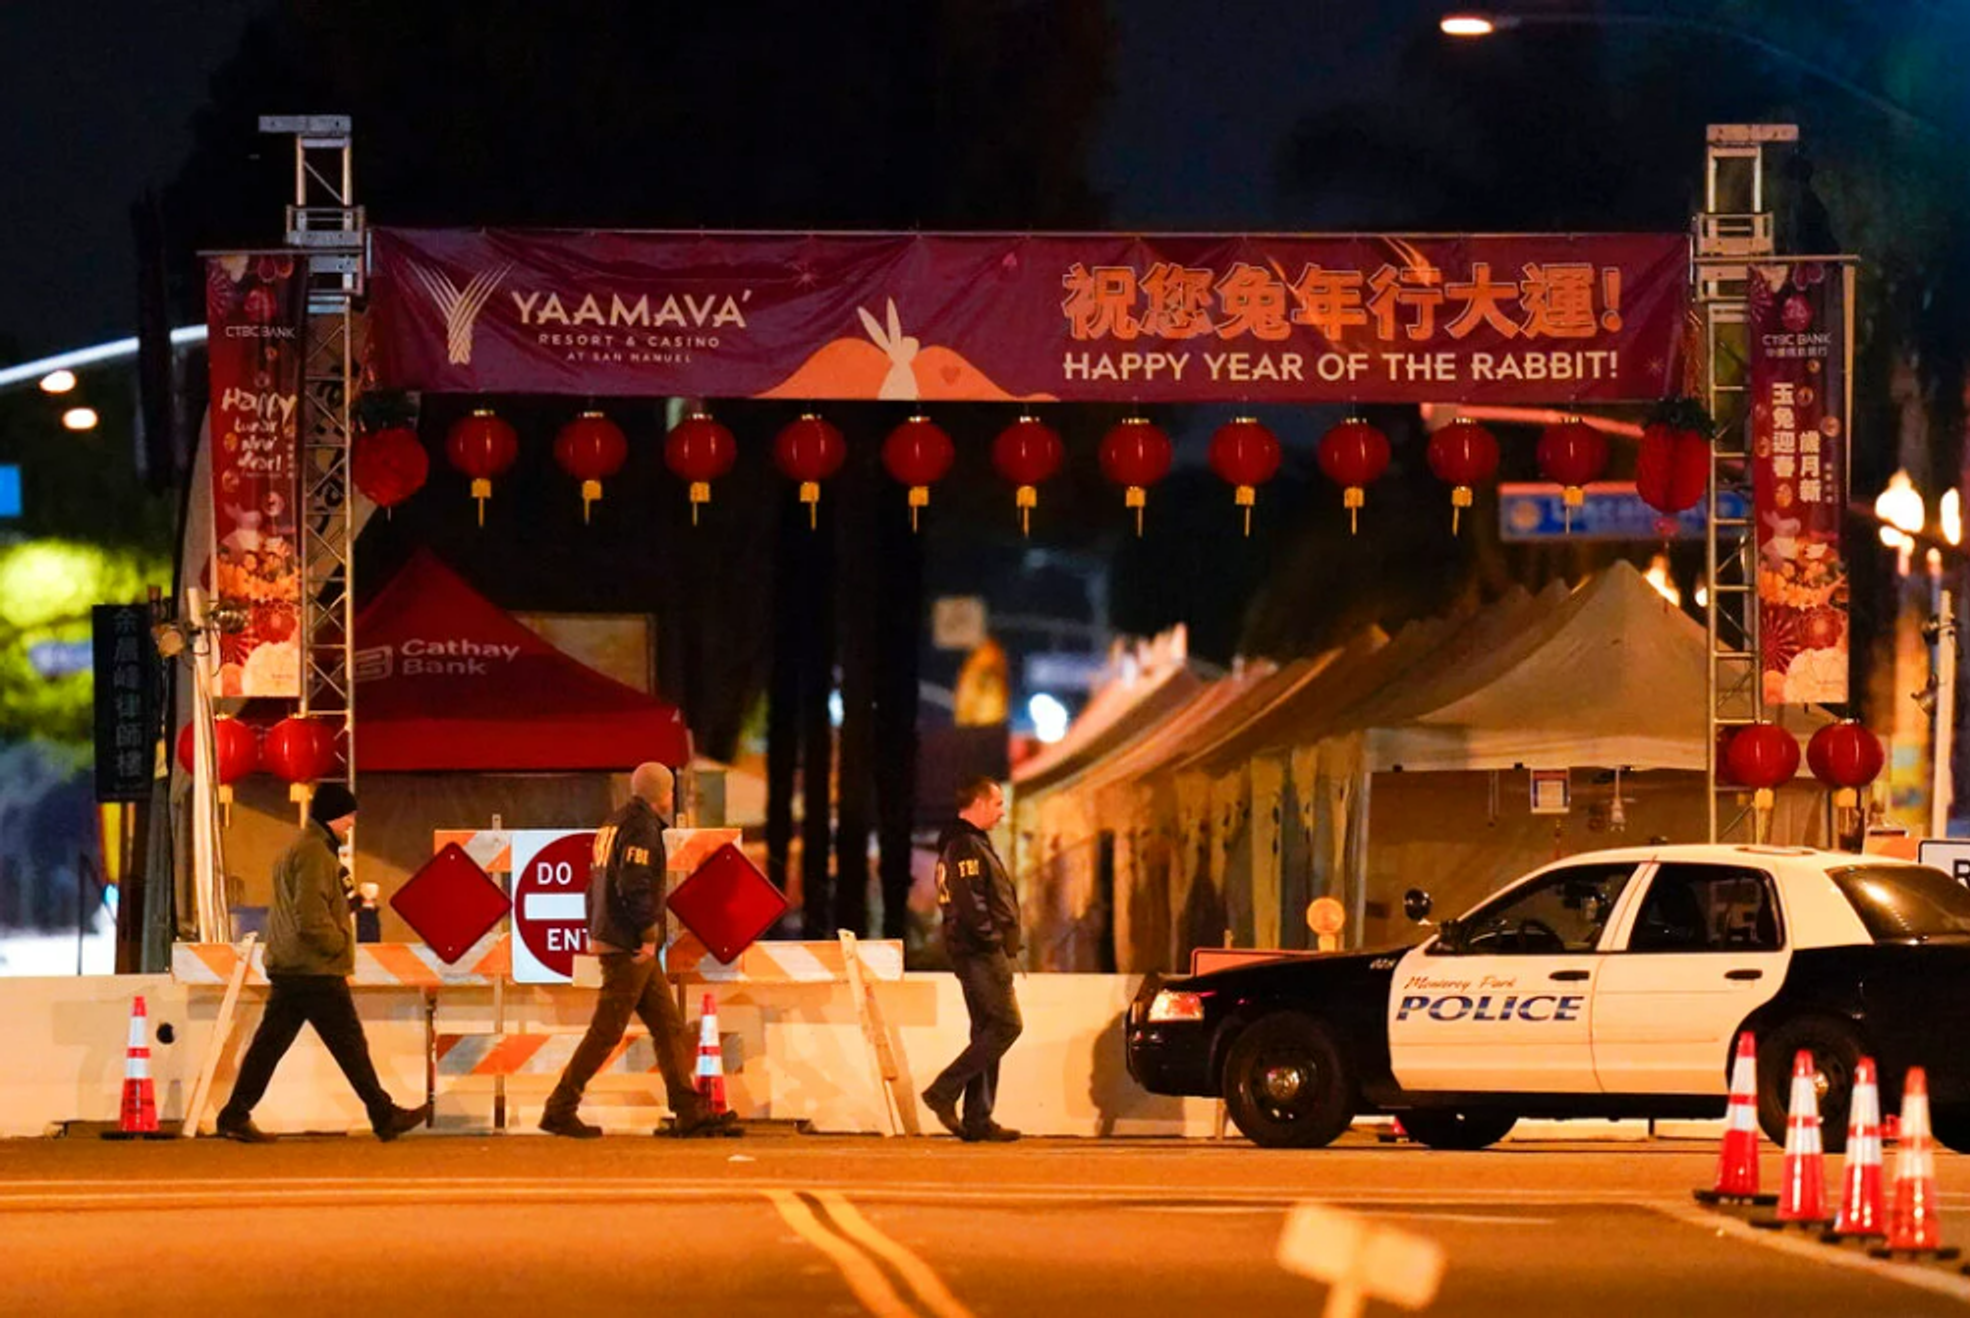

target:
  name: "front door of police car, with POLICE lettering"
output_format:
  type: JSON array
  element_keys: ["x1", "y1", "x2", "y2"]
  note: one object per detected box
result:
[{"x1": 1389, "y1": 861, "x2": 1635, "y2": 1093}]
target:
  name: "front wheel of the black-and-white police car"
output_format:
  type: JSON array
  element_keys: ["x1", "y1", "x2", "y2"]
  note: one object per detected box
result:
[{"x1": 1223, "y1": 1011, "x2": 1353, "y2": 1149}]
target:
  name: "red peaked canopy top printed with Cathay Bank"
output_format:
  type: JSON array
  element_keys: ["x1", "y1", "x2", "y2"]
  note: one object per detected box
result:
[{"x1": 355, "y1": 550, "x2": 690, "y2": 772}]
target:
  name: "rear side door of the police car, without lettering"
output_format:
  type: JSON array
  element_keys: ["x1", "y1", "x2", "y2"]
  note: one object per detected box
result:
[{"x1": 1594, "y1": 863, "x2": 1791, "y2": 1093}]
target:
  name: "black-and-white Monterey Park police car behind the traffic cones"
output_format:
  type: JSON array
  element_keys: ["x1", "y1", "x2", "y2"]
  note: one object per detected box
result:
[{"x1": 1127, "y1": 845, "x2": 1970, "y2": 1153}]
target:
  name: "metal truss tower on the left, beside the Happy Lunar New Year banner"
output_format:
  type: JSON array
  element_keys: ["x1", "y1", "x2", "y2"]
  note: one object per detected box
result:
[{"x1": 260, "y1": 114, "x2": 368, "y2": 784}]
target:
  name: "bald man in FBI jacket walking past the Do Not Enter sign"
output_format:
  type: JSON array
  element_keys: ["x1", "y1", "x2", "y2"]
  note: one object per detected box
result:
[{"x1": 540, "y1": 762, "x2": 745, "y2": 1139}]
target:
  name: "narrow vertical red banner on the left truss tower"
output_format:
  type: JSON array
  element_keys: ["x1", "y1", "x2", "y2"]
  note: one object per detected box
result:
[{"x1": 205, "y1": 256, "x2": 305, "y2": 697}]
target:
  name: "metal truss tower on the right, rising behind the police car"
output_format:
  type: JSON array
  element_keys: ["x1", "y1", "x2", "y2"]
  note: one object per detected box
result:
[{"x1": 1694, "y1": 124, "x2": 1799, "y2": 841}]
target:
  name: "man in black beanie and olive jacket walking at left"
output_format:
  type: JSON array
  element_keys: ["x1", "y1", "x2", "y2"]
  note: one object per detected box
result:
[{"x1": 219, "y1": 782, "x2": 431, "y2": 1145}]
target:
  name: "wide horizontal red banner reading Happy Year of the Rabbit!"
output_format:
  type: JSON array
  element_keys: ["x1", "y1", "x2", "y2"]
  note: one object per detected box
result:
[{"x1": 370, "y1": 229, "x2": 1688, "y2": 402}]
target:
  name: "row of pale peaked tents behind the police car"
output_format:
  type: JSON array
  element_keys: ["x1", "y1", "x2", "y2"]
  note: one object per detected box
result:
[{"x1": 1030, "y1": 563, "x2": 1826, "y2": 969}]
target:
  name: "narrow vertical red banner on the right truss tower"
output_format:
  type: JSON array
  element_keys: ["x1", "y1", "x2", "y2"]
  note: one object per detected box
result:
[{"x1": 1749, "y1": 262, "x2": 1848, "y2": 705}]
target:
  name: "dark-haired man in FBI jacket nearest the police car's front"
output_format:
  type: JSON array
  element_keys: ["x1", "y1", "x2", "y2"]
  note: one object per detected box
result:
[{"x1": 924, "y1": 778, "x2": 1020, "y2": 1145}]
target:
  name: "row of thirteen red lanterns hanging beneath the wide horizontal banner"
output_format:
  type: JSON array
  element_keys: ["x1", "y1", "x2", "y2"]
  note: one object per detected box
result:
[{"x1": 362, "y1": 398, "x2": 1686, "y2": 536}]
